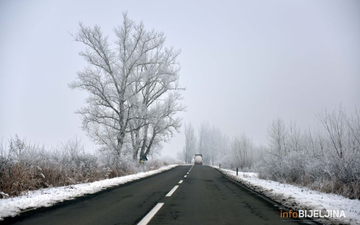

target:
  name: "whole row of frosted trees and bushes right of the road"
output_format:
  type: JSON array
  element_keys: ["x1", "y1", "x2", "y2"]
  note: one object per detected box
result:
[{"x1": 181, "y1": 107, "x2": 360, "y2": 199}]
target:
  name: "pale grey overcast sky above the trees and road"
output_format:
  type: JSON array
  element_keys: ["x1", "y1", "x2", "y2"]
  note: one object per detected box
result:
[{"x1": 0, "y1": 0, "x2": 360, "y2": 155}]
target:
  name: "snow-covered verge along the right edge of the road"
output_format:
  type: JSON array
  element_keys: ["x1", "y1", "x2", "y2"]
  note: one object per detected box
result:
[{"x1": 215, "y1": 167, "x2": 360, "y2": 224}]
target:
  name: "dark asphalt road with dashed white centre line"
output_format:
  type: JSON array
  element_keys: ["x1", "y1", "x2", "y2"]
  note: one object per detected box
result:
[{"x1": 0, "y1": 166, "x2": 316, "y2": 225}]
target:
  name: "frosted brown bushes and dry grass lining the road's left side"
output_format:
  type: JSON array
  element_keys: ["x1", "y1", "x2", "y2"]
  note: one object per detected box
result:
[{"x1": 0, "y1": 136, "x2": 174, "y2": 198}]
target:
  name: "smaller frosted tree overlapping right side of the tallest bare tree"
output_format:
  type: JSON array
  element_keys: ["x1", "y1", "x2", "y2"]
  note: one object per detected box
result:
[{"x1": 130, "y1": 49, "x2": 185, "y2": 159}]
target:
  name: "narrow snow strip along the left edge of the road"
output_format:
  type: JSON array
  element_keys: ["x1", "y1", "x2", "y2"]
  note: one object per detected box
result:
[{"x1": 0, "y1": 165, "x2": 177, "y2": 221}]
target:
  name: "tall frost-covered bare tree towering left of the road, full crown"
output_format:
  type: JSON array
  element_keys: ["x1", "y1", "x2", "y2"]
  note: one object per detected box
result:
[{"x1": 69, "y1": 13, "x2": 180, "y2": 159}]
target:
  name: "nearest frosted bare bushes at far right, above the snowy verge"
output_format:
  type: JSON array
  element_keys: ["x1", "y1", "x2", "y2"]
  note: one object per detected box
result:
[{"x1": 256, "y1": 108, "x2": 360, "y2": 199}]
